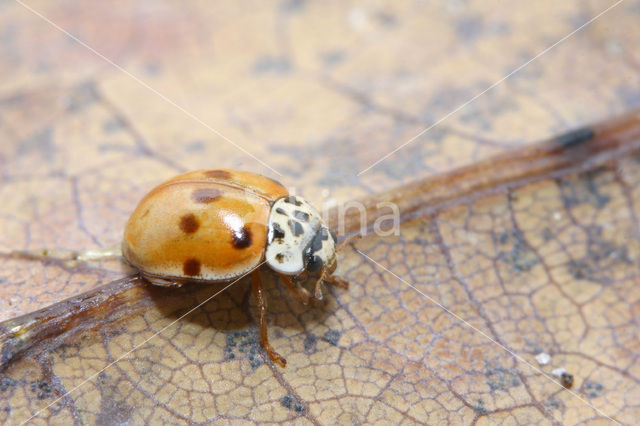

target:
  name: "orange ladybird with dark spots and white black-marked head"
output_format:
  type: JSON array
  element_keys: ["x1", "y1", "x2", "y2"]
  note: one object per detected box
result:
[{"x1": 122, "y1": 169, "x2": 347, "y2": 367}]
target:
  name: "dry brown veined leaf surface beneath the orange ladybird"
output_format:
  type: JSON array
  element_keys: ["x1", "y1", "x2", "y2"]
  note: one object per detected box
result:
[{"x1": 0, "y1": 1, "x2": 640, "y2": 424}]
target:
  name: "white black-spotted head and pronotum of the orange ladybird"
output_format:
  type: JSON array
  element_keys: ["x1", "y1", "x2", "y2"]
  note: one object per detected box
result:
[{"x1": 265, "y1": 195, "x2": 336, "y2": 275}]
